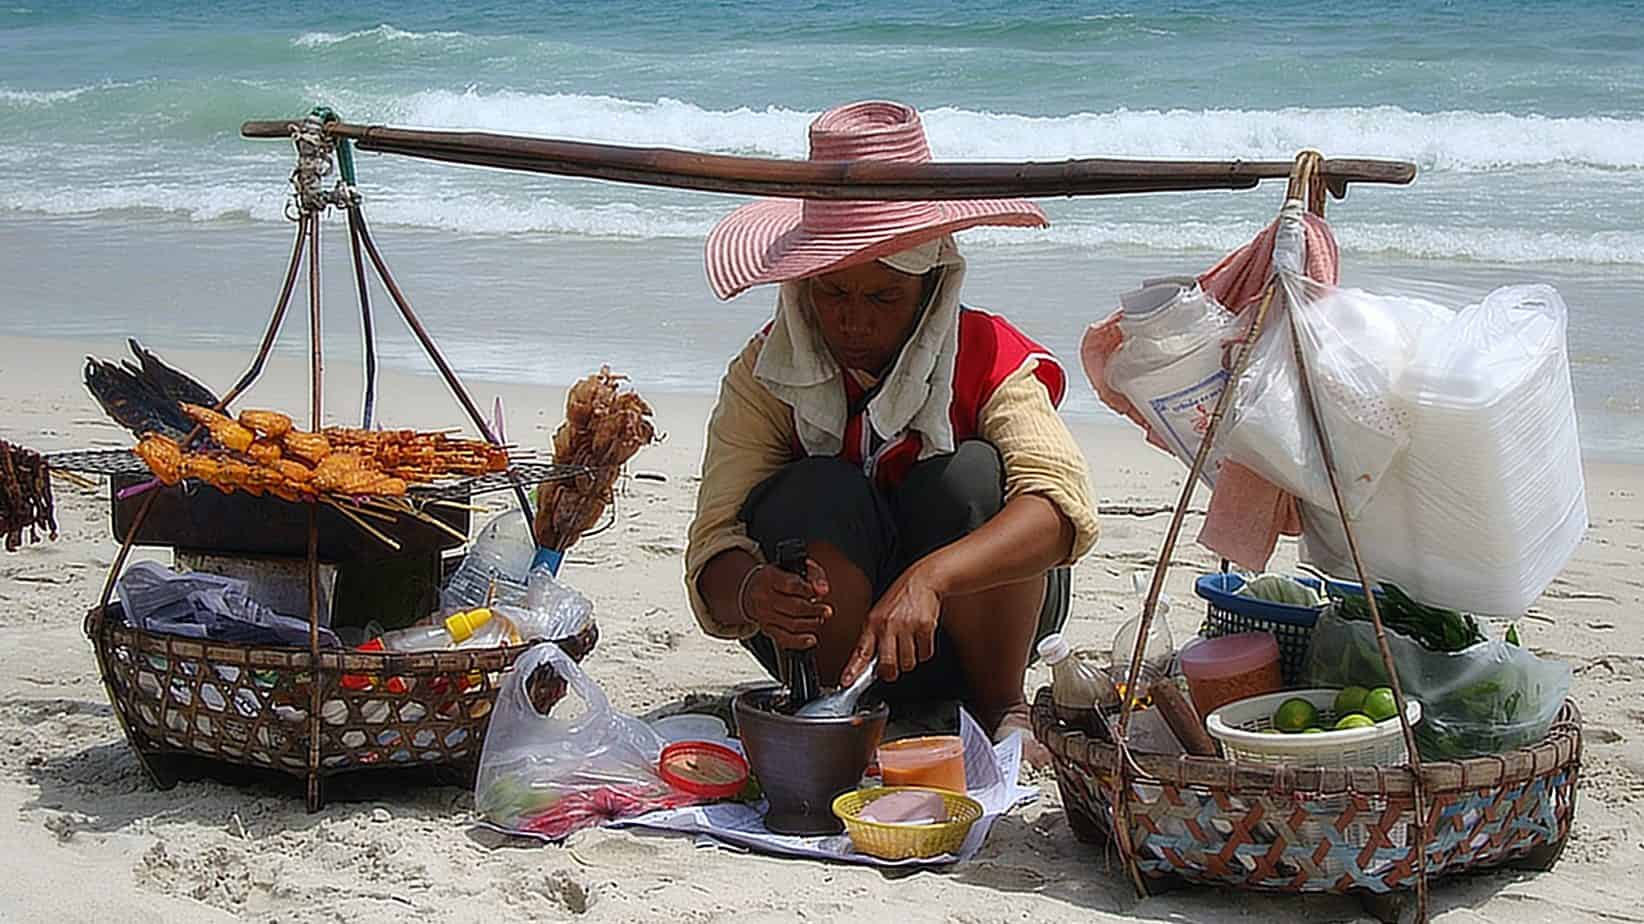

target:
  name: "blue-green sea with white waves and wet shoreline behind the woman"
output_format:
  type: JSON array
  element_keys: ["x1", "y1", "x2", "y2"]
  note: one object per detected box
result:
[{"x1": 0, "y1": 0, "x2": 1644, "y2": 455}]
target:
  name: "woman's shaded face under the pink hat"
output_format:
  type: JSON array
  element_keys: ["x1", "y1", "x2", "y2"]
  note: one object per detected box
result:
[{"x1": 806, "y1": 260, "x2": 926, "y2": 373}]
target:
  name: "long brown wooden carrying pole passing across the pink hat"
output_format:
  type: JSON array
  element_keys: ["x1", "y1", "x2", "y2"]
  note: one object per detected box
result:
[{"x1": 240, "y1": 120, "x2": 1415, "y2": 199}]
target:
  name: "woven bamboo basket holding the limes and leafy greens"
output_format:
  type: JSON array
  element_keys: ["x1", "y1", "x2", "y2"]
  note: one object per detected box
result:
[{"x1": 1032, "y1": 687, "x2": 1582, "y2": 894}]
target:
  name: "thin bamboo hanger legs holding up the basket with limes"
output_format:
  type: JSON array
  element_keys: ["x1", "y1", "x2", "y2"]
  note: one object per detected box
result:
[{"x1": 1113, "y1": 151, "x2": 1429, "y2": 924}]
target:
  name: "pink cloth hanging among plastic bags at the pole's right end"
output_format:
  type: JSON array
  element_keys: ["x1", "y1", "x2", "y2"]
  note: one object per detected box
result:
[{"x1": 1078, "y1": 212, "x2": 1342, "y2": 571}]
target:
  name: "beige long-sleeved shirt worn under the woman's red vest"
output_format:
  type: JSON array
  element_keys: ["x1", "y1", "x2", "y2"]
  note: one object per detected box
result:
[{"x1": 686, "y1": 337, "x2": 1098, "y2": 638}]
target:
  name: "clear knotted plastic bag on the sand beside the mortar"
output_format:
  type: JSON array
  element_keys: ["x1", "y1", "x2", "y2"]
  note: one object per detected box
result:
[{"x1": 473, "y1": 643, "x2": 697, "y2": 840}]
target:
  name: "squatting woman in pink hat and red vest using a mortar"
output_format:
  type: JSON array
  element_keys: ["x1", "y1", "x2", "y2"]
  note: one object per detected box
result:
[{"x1": 686, "y1": 102, "x2": 1097, "y2": 745}]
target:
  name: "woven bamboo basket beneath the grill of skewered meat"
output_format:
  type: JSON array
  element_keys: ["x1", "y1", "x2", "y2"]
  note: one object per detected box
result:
[{"x1": 85, "y1": 603, "x2": 598, "y2": 799}]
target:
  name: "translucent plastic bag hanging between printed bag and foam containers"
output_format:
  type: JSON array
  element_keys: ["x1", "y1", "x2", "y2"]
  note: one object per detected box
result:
[{"x1": 1218, "y1": 273, "x2": 1450, "y2": 516}]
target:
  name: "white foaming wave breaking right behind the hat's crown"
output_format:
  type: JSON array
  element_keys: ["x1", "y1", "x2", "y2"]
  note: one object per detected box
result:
[{"x1": 378, "y1": 87, "x2": 1644, "y2": 173}]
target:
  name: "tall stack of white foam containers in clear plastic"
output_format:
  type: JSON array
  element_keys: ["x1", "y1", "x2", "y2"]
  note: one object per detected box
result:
[{"x1": 1302, "y1": 284, "x2": 1586, "y2": 617}]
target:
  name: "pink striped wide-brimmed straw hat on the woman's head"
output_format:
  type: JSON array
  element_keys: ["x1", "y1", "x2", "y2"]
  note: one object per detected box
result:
[{"x1": 707, "y1": 100, "x2": 1051, "y2": 299}]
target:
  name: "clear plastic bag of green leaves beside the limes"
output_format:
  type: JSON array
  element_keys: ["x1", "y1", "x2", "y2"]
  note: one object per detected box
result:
[{"x1": 1307, "y1": 607, "x2": 1572, "y2": 760}]
